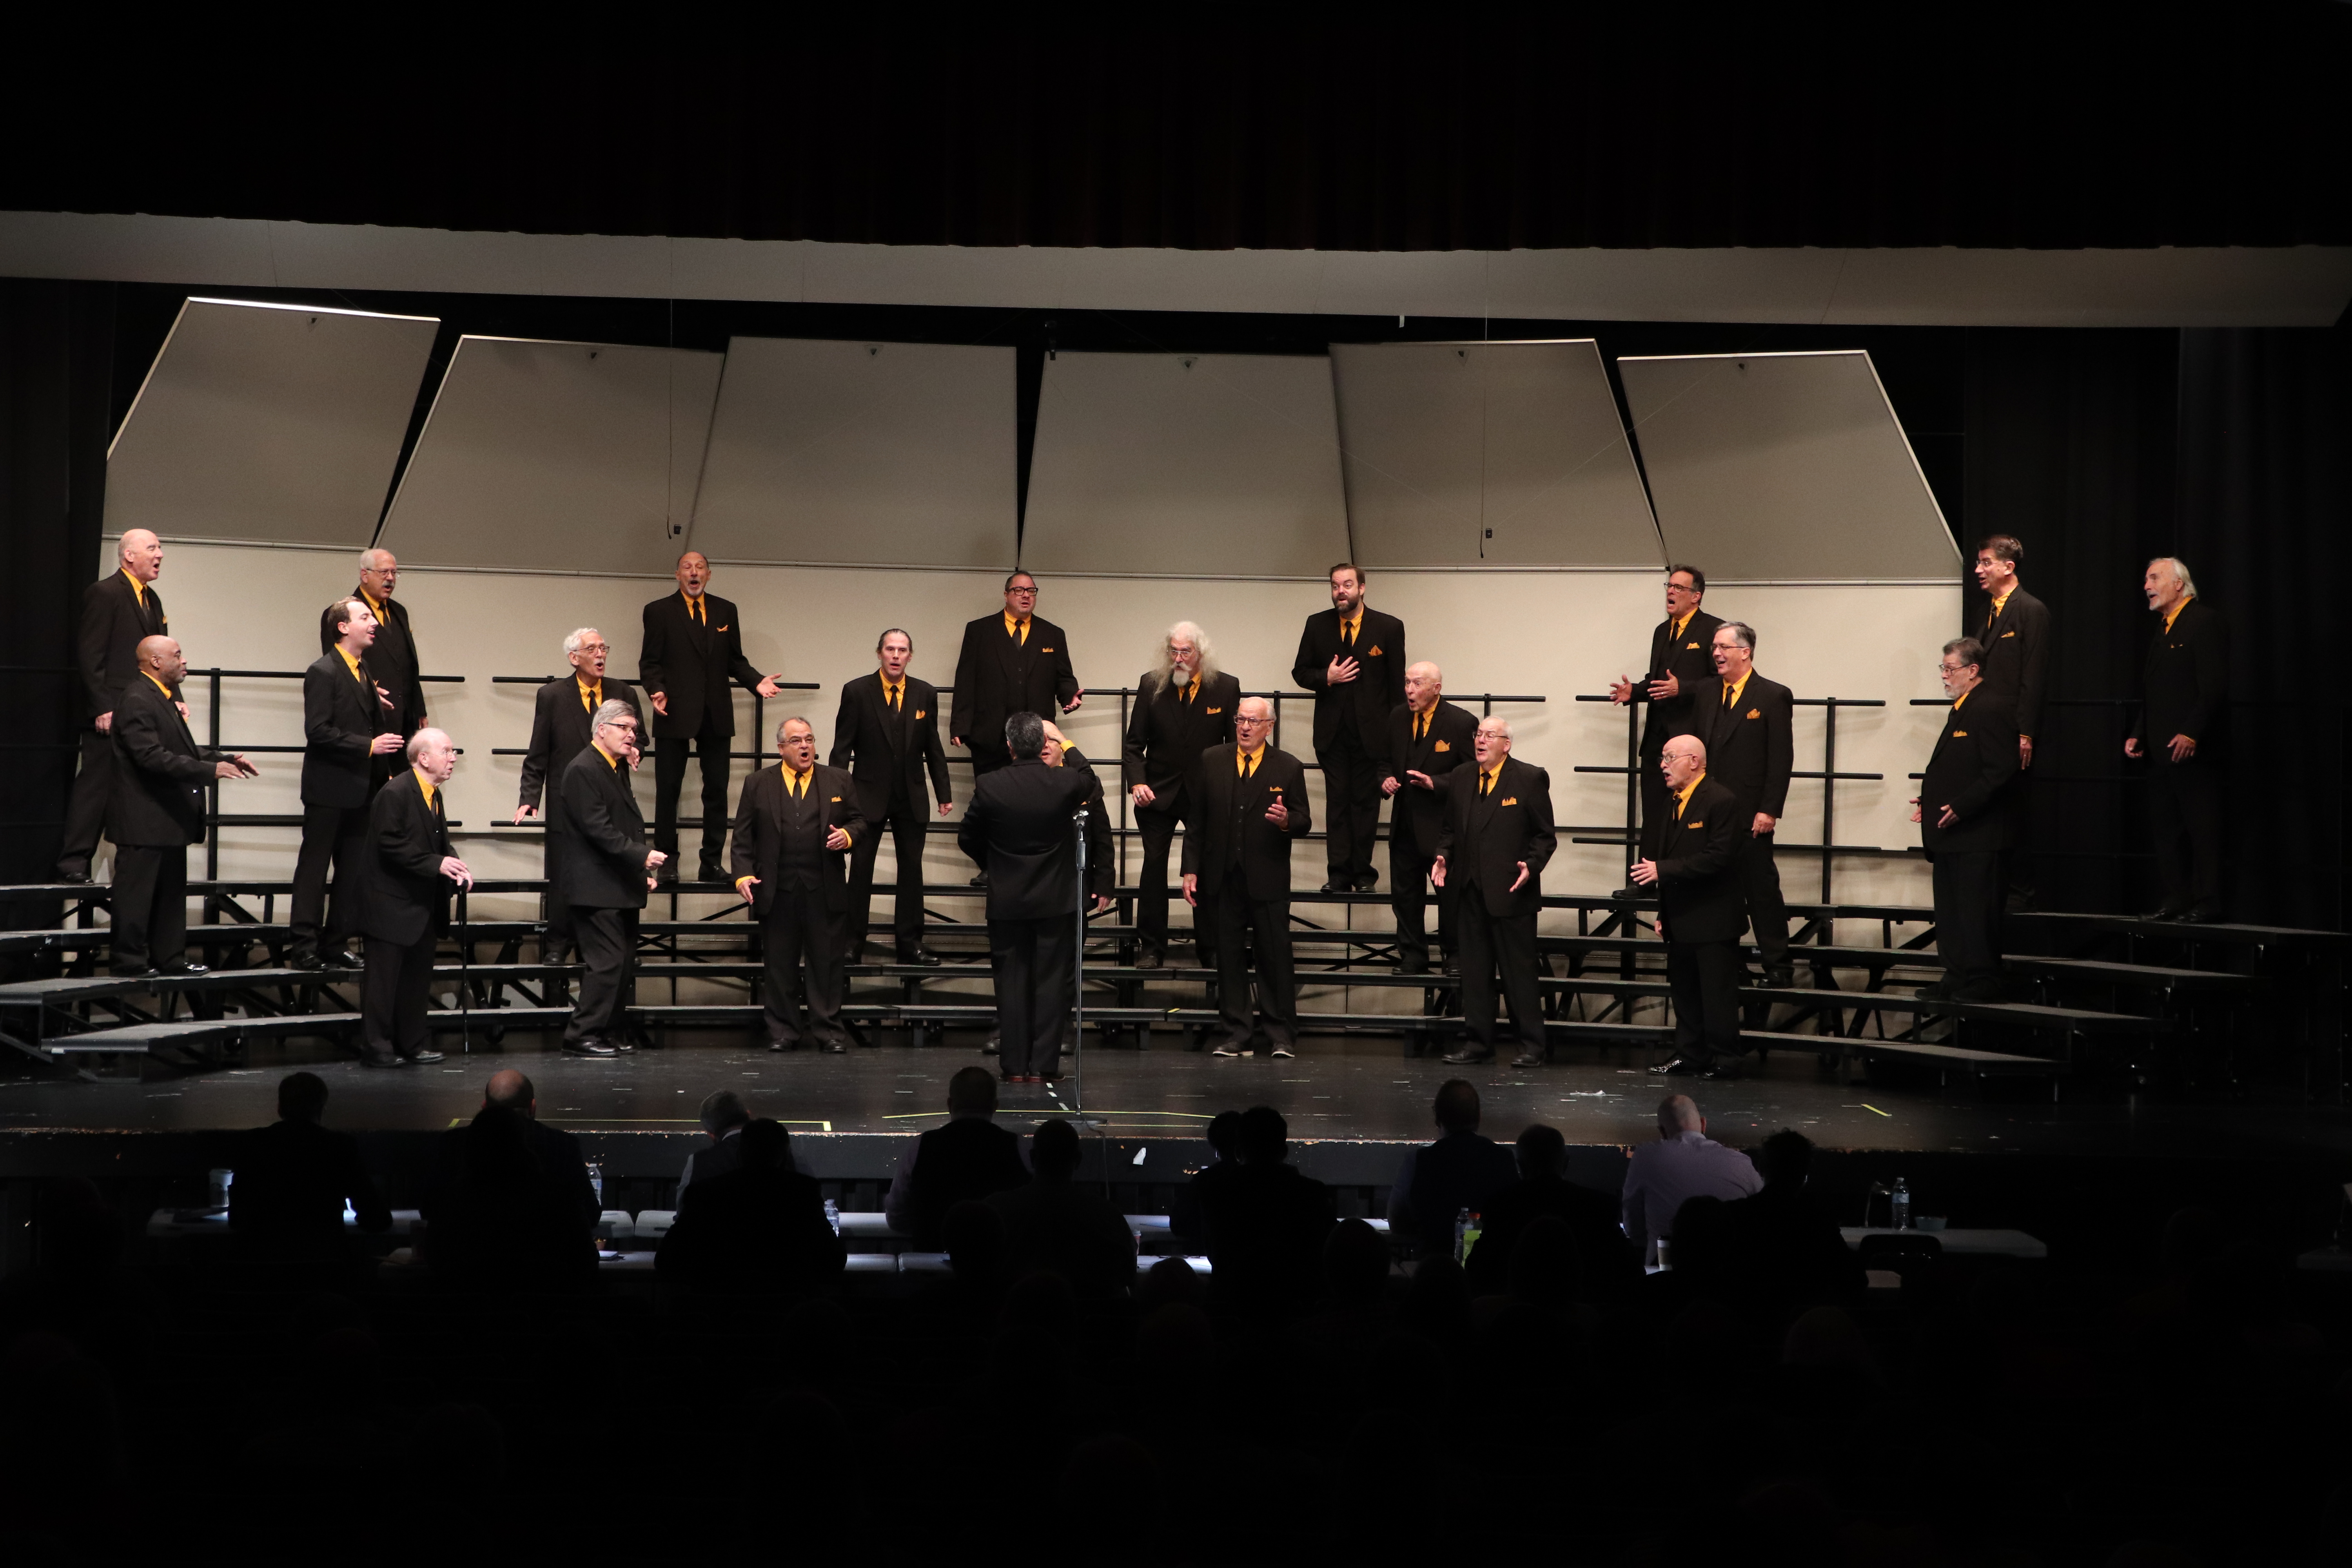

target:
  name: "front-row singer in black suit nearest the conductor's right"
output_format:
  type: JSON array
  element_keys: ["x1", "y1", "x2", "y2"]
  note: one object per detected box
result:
[{"x1": 1183, "y1": 696, "x2": 1315, "y2": 1058}]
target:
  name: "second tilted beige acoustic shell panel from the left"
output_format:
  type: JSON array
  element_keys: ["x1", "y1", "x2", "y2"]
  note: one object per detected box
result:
[{"x1": 381, "y1": 336, "x2": 720, "y2": 573}]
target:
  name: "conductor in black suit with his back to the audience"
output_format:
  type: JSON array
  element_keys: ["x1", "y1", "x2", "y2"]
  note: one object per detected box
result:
[{"x1": 955, "y1": 712, "x2": 1108, "y2": 1084}]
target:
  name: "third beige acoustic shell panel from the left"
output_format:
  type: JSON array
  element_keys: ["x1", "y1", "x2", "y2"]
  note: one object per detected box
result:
[{"x1": 691, "y1": 339, "x2": 1018, "y2": 566}]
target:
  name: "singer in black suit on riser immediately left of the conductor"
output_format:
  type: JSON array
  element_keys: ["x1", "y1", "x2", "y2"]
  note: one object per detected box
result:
[{"x1": 828, "y1": 625, "x2": 955, "y2": 964}]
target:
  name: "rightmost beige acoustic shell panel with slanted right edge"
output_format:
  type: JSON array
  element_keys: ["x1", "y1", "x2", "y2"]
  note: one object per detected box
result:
[{"x1": 1618, "y1": 348, "x2": 1959, "y2": 583}]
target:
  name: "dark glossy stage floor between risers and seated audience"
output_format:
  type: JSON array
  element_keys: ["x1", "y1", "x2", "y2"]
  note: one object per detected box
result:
[{"x1": 0, "y1": 1030, "x2": 2352, "y2": 1157}]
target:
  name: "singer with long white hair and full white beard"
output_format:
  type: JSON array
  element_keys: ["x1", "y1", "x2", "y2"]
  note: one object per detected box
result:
[{"x1": 1120, "y1": 621, "x2": 1242, "y2": 969}]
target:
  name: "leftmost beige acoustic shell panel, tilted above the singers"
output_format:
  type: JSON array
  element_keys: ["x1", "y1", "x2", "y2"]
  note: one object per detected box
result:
[{"x1": 106, "y1": 299, "x2": 440, "y2": 550}]
